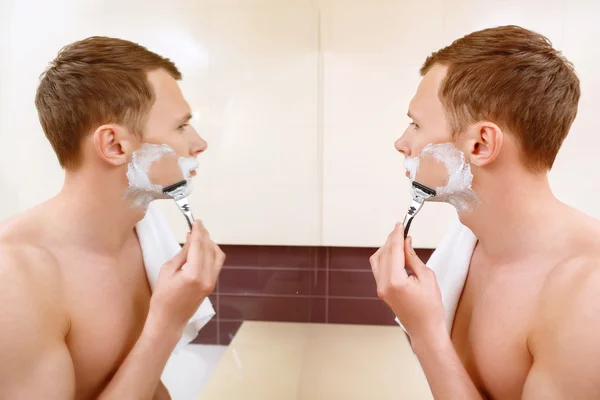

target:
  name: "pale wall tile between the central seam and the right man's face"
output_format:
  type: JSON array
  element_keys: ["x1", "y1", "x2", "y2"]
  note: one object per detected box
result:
[{"x1": 321, "y1": 0, "x2": 452, "y2": 247}]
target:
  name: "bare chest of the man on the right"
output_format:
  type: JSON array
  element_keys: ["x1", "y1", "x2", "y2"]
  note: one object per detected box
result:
[{"x1": 452, "y1": 256, "x2": 542, "y2": 399}]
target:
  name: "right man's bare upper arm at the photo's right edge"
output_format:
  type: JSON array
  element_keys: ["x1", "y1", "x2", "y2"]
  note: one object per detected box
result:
[{"x1": 522, "y1": 263, "x2": 600, "y2": 400}]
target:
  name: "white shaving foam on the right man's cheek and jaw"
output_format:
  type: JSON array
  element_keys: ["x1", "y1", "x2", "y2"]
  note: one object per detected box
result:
[{"x1": 404, "y1": 143, "x2": 480, "y2": 214}]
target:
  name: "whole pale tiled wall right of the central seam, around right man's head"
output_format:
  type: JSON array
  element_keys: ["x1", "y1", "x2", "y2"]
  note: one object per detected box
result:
[{"x1": 322, "y1": 0, "x2": 600, "y2": 247}]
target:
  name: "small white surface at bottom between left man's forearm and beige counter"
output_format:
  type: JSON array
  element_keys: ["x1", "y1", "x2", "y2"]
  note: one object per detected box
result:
[{"x1": 162, "y1": 344, "x2": 227, "y2": 400}]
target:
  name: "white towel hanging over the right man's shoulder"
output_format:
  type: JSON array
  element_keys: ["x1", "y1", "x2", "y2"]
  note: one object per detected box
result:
[{"x1": 396, "y1": 218, "x2": 477, "y2": 332}]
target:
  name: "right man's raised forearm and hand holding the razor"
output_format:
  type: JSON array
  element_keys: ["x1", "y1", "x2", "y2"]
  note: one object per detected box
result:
[{"x1": 370, "y1": 224, "x2": 482, "y2": 400}]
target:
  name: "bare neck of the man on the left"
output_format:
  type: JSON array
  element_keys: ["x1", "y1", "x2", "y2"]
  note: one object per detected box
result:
[{"x1": 54, "y1": 170, "x2": 144, "y2": 254}]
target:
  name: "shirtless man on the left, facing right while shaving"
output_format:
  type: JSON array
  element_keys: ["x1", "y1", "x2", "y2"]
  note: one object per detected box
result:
[{"x1": 0, "y1": 37, "x2": 224, "y2": 400}]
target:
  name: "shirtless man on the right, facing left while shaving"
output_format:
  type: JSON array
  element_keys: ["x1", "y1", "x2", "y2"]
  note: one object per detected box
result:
[{"x1": 371, "y1": 26, "x2": 600, "y2": 400}]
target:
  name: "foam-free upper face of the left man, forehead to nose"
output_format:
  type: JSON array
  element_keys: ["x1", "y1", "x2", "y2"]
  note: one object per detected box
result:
[{"x1": 144, "y1": 70, "x2": 207, "y2": 177}]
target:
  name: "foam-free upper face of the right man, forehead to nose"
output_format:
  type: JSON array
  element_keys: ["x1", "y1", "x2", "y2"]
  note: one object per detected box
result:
[{"x1": 395, "y1": 65, "x2": 452, "y2": 162}]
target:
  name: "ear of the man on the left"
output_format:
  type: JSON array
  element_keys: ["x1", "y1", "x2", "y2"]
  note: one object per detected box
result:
[{"x1": 93, "y1": 124, "x2": 136, "y2": 166}]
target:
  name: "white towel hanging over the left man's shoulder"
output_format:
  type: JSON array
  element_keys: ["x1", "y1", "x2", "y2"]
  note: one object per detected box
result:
[{"x1": 135, "y1": 202, "x2": 215, "y2": 345}]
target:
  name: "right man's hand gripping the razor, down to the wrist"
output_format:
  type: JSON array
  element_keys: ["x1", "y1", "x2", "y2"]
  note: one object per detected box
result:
[{"x1": 370, "y1": 223, "x2": 448, "y2": 343}]
